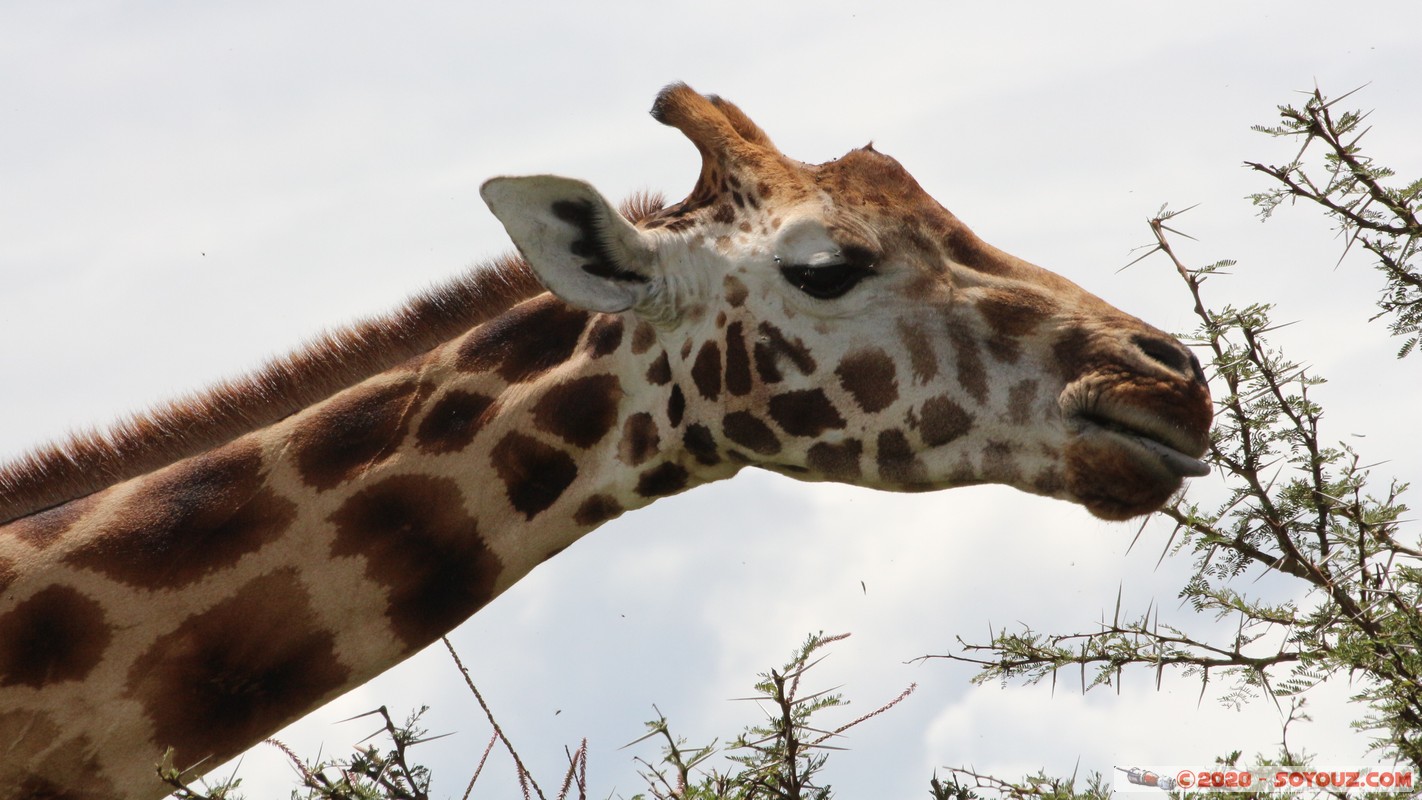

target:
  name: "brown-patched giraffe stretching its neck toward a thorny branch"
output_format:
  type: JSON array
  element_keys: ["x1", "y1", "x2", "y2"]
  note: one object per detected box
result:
[{"x1": 0, "y1": 84, "x2": 1212, "y2": 800}]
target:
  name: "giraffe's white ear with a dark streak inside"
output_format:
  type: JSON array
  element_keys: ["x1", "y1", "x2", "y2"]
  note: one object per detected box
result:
[{"x1": 479, "y1": 175, "x2": 657, "y2": 313}]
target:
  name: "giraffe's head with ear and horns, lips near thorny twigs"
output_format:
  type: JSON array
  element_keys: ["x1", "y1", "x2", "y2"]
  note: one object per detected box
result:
[{"x1": 483, "y1": 84, "x2": 1212, "y2": 519}]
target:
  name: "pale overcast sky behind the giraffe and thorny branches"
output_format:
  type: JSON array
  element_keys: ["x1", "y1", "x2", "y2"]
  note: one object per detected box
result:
[{"x1": 0, "y1": 0, "x2": 1422, "y2": 799}]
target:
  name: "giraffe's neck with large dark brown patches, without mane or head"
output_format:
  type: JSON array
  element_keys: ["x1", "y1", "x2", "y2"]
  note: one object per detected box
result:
[{"x1": 0, "y1": 296, "x2": 693, "y2": 797}]
